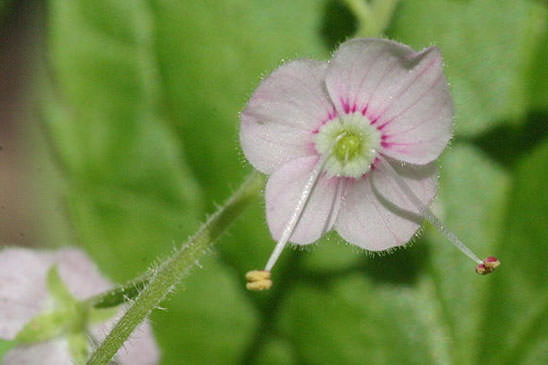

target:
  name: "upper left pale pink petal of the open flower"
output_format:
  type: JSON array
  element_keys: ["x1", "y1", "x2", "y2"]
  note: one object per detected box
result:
[{"x1": 240, "y1": 59, "x2": 334, "y2": 174}]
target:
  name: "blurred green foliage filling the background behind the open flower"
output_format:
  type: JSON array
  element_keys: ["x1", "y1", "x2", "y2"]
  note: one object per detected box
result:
[{"x1": 33, "y1": 0, "x2": 548, "y2": 365}]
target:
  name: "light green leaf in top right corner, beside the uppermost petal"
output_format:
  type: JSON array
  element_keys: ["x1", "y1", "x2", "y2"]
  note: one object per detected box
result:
[{"x1": 389, "y1": 0, "x2": 548, "y2": 135}]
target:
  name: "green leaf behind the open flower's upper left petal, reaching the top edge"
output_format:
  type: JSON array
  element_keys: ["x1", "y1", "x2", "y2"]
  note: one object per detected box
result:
[{"x1": 149, "y1": 0, "x2": 328, "y2": 201}]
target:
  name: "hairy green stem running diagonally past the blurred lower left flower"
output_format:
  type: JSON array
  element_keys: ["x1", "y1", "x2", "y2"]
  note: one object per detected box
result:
[{"x1": 88, "y1": 172, "x2": 264, "y2": 365}]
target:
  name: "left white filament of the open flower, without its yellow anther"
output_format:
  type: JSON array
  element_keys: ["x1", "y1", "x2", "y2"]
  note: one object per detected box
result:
[{"x1": 265, "y1": 133, "x2": 345, "y2": 271}]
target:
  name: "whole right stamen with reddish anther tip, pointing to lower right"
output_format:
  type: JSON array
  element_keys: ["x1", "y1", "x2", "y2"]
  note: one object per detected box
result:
[{"x1": 378, "y1": 155, "x2": 500, "y2": 274}]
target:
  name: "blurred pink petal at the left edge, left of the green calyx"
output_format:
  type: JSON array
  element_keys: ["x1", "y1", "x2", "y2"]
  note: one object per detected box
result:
[{"x1": 0, "y1": 248, "x2": 53, "y2": 340}]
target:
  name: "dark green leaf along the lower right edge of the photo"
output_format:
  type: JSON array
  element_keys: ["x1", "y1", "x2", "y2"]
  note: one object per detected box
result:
[{"x1": 480, "y1": 140, "x2": 548, "y2": 364}]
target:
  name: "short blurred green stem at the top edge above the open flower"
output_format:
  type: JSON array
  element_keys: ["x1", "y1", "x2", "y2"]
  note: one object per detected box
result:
[{"x1": 344, "y1": 0, "x2": 399, "y2": 37}]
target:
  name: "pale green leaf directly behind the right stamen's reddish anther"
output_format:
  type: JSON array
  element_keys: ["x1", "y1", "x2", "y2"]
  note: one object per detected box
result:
[{"x1": 427, "y1": 144, "x2": 511, "y2": 364}]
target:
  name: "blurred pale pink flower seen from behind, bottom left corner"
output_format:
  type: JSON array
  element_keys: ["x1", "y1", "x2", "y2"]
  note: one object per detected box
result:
[{"x1": 0, "y1": 248, "x2": 159, "y2": 365}]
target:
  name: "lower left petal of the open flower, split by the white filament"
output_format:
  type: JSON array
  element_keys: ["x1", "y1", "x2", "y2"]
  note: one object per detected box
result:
[{"x1": 265, "y1": 156, "x2": 344, "y2": 245}]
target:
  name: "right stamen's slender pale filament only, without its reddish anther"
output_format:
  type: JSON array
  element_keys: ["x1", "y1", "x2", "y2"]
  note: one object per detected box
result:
[{"x1": 378, "y1": 156, "x2": 483, "y2": 264}]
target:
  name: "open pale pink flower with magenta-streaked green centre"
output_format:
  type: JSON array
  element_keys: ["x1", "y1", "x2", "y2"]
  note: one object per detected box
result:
[{"x1": 240, "y1": 39, "x2": 496, "y2": 282}]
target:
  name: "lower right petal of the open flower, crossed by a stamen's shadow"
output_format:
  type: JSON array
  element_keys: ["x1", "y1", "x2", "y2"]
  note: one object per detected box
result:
[{"x1": 335, "y1": 161, "x2": 437, "y2": 251}]
